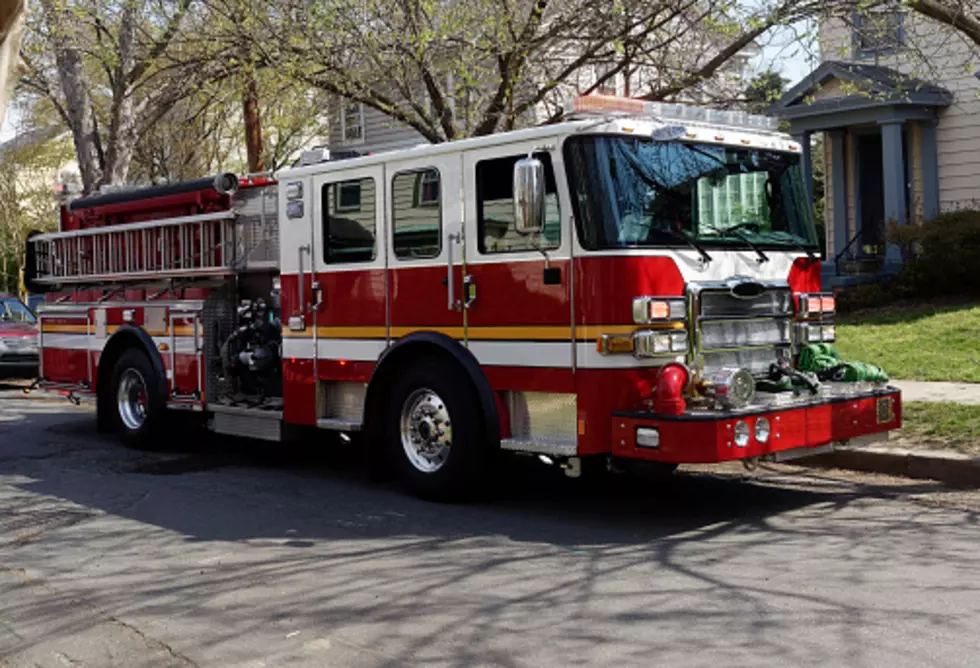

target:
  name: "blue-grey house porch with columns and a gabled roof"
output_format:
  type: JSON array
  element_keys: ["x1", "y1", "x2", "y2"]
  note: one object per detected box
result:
[{"x1": 771, "y1": 61, "x2": 952, "y2": 289}]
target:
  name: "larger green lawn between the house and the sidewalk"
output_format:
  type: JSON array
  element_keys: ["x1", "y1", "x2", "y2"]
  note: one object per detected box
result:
[{"x1": 837, "y1": 304, "x2": 980, "y2": 383}]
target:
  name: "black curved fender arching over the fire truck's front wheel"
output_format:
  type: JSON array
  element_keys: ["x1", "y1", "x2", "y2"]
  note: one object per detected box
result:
[{"x1": 364, "y1": 331, "x2": 500, "y2": 445}]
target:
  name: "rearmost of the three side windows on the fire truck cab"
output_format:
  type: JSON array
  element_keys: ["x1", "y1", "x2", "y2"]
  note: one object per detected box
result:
[{"x1": 321, "y1": 178, "x2": 377, "y2": 264}]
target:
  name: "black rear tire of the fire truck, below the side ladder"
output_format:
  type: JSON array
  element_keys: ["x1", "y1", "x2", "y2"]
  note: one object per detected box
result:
[{"x1": 105, "y1": 348, "x2": 167, "y2": 450}]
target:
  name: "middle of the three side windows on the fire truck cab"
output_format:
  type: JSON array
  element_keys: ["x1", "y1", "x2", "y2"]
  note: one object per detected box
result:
[{"x1": 391, "y1": 168, "x2": 442, "y2": 260}]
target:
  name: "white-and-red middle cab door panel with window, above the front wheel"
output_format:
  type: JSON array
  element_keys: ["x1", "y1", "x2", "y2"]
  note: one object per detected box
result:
[{"x1": 386, "y1": 153, "x2": 464, "y2": 340}]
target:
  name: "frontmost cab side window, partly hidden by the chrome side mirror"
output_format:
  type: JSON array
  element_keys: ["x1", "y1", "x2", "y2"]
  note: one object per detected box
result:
[{"x1": 476, "y1": 153, "x2": 561, "y2": 253}]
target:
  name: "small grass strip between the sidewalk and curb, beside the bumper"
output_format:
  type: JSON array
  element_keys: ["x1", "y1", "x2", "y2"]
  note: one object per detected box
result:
[{"x1": 899, "y1": 402, "x2": 980, "y2": 455}]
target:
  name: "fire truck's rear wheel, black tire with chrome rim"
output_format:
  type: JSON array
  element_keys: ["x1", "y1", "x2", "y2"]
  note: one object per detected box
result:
[{"x1": 107, "y1": 349, "x2": 166, "y2": 450}]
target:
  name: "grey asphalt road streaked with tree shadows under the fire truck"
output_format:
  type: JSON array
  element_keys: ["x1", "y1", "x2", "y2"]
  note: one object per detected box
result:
[{"x1": 0, "y1": 386, "x2": 980, "y2": 668}]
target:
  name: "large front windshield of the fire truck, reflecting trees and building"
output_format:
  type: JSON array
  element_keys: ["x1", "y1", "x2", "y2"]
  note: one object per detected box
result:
[{"x1": 565, "y1": 135, "x2": 816, "y2": 250}]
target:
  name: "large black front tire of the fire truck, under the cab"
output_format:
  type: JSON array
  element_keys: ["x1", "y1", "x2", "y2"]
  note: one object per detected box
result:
[{"x1": 384, "y1": 357, "x2": 490, "y2": 501}]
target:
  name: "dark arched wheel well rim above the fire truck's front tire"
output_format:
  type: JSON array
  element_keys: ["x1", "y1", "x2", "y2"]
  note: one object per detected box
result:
[{"x1": 364, "y1": 332, "x2": 501, "y2": 444}]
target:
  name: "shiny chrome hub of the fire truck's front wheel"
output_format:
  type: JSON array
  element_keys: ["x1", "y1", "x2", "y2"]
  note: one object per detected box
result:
[{"x1": 400, "y1": 388, "x2": 453, "y2": 473}]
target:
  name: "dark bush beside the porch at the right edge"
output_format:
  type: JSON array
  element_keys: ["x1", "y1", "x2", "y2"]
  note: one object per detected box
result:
[{"x1": 888, "y1": 210, "x2": 980, "y2": 297}]
